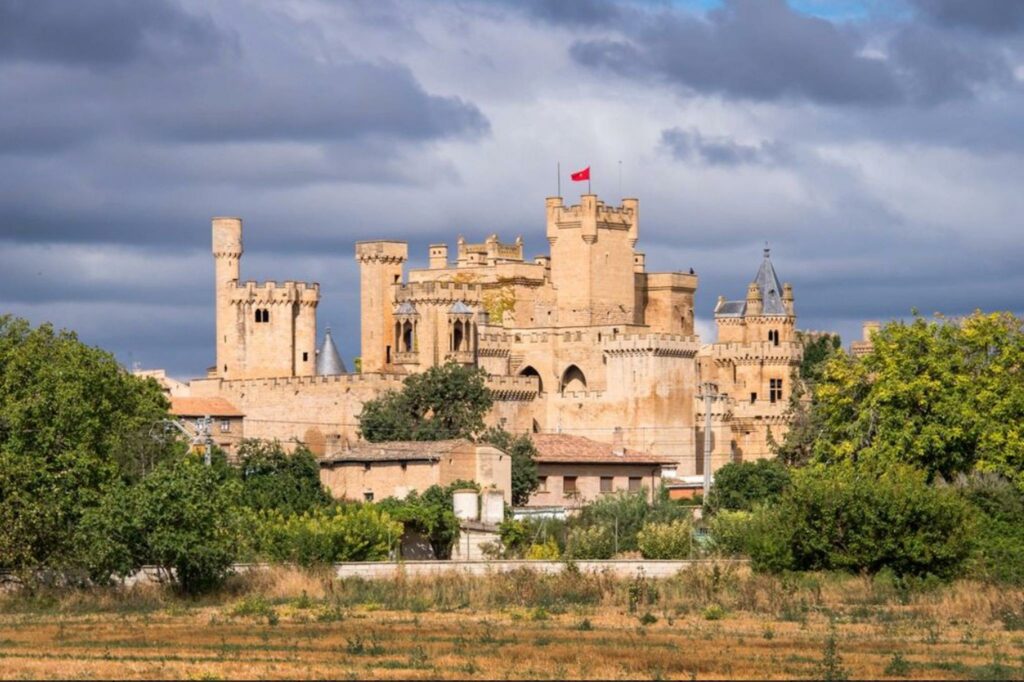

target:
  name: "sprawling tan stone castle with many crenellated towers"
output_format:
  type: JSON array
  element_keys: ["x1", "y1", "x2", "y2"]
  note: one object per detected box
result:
[{"x1": 191, "y1": 195, "x2": 803, "y2": 475}]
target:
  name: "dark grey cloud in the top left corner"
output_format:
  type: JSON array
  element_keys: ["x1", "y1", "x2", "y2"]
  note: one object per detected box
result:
[{"x1": 0, "y1": 0, "x2": 228, "y2": 68}]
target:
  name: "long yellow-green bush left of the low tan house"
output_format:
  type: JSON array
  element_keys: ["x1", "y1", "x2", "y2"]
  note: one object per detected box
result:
[{"x1": 249, "y1": 505, "x2": 402, "y2": 566}]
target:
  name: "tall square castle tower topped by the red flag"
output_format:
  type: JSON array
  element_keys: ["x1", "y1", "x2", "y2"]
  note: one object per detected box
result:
[{"x1": 547, "y1": 195, "x2": 640, "y2": 326}]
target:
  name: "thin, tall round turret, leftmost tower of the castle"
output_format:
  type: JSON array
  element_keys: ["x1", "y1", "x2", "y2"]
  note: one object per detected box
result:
[{"x1": 212, "y1": 217, "x2": 245, "y2": 379}]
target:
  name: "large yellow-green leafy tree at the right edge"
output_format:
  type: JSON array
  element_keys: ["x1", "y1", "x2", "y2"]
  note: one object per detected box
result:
[{"x1": 813, "y1": 312, "x2": 1024, "y2": 488}]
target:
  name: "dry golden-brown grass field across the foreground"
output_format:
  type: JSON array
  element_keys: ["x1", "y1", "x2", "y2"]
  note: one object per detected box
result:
[{"x1": 0, "y1": 566, "x2": 1024, "y2": 679}]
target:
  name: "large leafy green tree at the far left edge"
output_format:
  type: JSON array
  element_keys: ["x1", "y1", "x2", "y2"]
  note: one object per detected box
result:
[{"x1": 0, "y1": 315, "x2": 173, "y2": 579}]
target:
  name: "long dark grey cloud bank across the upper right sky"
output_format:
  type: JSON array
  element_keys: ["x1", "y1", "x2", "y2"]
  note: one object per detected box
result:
[{"x1": 570, "y1": 0, "x2": 1011, "y2": 106}]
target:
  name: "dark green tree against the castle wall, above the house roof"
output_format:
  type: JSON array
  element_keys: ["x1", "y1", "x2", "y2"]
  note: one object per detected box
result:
[{"x1": 359, "y1": 363, "x2": 494, "y2": 442}]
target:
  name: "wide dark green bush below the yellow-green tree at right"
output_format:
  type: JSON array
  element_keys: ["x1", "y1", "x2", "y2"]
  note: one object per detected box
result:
[{"x1": 751, "y1": 464, "x2": 975, "y2": 579}]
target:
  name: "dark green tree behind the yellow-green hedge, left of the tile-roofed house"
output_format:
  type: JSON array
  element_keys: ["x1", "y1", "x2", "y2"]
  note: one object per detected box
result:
[{"x1": 238, "y1": 439, "x2": 331, "y2": 514}]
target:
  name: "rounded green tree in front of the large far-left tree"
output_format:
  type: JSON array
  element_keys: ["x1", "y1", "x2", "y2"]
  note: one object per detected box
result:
[{"x1": 80, "y1": 455, "x2": 240, "y2": 594}]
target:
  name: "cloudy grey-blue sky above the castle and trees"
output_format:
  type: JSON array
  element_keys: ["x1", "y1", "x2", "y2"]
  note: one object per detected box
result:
[{"x1": 0, "y1": 0, "x2": 1024, "y2": 378}]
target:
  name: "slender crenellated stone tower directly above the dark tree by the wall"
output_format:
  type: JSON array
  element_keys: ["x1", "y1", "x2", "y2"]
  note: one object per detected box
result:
[{"x1": 355, "y1": 241, "x2": 409, "y2": 372}]
